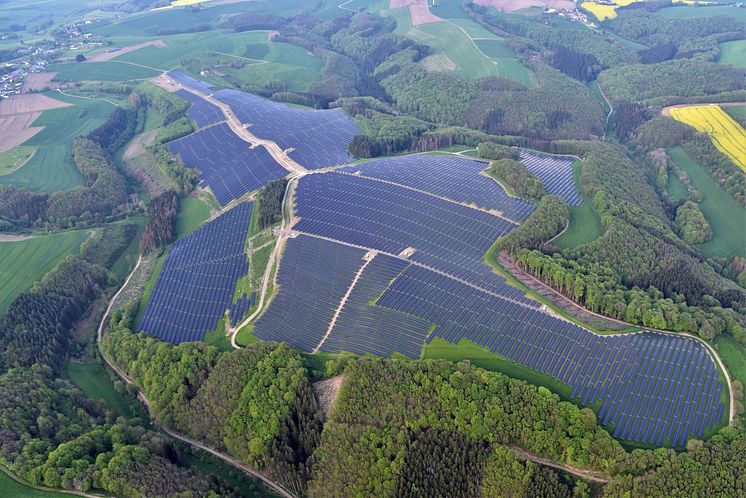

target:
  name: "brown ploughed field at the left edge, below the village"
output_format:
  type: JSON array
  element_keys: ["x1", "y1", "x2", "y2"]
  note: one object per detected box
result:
[{"x1": 0, "y1": 93, "x2": 70, "y2": 152}]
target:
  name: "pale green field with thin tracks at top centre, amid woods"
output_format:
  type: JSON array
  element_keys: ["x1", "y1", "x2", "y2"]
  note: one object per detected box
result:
[{"x1": 387, "y1": 7, "x2": 534, "y2": 86}]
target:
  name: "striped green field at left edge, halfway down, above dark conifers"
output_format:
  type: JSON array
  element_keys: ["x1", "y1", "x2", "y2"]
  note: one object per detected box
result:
[{"x1": 0, "y1": 230, "x2": 90, "y2": 313}]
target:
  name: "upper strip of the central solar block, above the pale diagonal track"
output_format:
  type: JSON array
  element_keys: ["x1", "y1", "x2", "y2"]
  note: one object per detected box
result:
[{"x1": 340, "y1": 154, "x2": 535, "y2": 221}]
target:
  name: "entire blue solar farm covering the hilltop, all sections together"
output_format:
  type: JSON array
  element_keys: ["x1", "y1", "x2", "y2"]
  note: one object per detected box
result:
[{"x1": 135, "y1": 73, "x2": 725, "y2": 446}]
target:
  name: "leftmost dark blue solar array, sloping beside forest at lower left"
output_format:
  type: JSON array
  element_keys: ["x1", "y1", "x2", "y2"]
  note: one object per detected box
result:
[{"x1": 139, "y1": 203, "x2": 253, "y2": 343}]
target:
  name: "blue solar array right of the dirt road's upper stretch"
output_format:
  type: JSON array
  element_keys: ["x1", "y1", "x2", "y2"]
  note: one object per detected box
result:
[{"x1": 215, "y1": 90, "x2": 360, "y2": 169}]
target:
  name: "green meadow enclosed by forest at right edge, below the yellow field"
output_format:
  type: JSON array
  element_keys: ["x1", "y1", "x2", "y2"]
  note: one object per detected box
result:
[{"x1": 668, "y1": 147, "x2": 746, "y2": 258}]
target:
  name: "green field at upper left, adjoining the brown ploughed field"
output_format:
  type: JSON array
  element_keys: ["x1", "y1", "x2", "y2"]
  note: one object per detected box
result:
[{"x1": 0, "y1": 92, "x2": 114, "y2": 192}]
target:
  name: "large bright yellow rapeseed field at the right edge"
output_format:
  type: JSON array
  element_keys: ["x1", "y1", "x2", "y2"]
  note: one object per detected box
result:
[{"x1": 670, "y1": 105, "x2": 746, "y2": 171}]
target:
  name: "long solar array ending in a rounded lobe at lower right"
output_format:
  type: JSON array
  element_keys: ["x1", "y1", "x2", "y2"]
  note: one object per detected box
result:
[{"x1": 377, "y1": 265, "x2": 723, "y2": 445}]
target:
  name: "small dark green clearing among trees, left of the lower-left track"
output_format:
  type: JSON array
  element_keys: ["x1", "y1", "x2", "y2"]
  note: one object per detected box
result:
[{"x1": 67, "y1": 361, "x2": 147, "y2": 420}]
